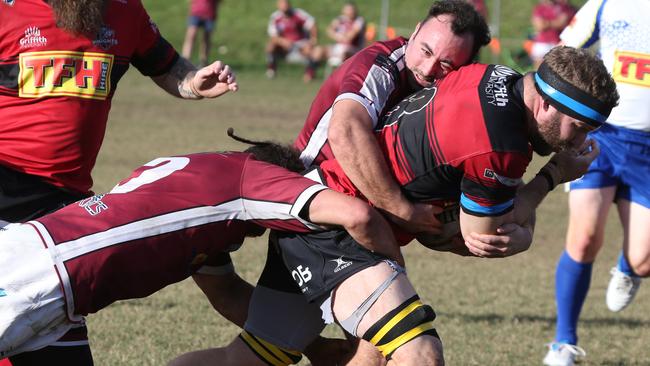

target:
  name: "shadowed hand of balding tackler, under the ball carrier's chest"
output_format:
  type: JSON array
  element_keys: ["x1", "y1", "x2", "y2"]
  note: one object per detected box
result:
[{"x1": 389, "y1": 201, "x2": 443, "y2": 234}]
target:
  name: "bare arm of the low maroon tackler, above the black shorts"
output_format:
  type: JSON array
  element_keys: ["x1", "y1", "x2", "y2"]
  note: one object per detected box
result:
[{"x1": 306, "y1": 189, "x2": 404, "y2": 263}]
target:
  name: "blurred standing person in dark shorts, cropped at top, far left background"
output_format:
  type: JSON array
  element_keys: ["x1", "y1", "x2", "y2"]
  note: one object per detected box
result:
[{"x1": 182, "y1": 0, "x2": 221, "y2": 67}]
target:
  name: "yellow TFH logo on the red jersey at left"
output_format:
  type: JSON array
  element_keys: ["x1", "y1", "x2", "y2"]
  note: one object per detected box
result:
[{"x1": 18, "y1": 51, "x2": 113, "y2": 100}]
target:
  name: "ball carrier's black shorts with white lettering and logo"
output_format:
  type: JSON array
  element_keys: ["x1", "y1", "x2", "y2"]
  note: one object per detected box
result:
[{"x1": 268, "y1": 230, "x2": 388, "y2": 302}]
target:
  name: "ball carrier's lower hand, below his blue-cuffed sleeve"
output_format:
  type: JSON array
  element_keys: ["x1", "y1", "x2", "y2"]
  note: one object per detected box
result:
[{"x1": 465, "y1": 224, "x2": 533, "y2": 258}]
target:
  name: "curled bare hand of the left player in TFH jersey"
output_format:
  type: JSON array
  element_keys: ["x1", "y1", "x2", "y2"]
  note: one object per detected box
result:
[{"x1": 190, "y1": 61, "x2": 239, "y2": 98}]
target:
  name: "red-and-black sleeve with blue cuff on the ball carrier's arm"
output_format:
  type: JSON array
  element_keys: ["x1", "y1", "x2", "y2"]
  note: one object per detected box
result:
[{"x1": 460, "y1": 152, "x2": 530, "y2": 216}]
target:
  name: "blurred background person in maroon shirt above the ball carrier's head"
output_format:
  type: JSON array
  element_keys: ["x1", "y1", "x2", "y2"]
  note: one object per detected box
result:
[{"x1": 530, "y1": 0, "x2": 575, "y2": 68}]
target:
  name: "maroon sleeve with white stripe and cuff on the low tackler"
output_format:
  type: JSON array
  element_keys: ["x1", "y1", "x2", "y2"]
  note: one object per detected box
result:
[{"x1": 241, "y1": 158, "x2": 327, "y2": 232}]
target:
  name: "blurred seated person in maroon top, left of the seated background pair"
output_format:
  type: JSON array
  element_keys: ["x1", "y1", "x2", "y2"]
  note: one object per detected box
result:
[{"x1": 266, "y1": 0, "x2": 318, "y2": 82}]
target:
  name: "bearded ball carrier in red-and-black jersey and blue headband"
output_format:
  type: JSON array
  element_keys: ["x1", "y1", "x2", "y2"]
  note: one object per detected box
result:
[{"x1": 172, "y1": 47, "x2": 618, "y2": 366}]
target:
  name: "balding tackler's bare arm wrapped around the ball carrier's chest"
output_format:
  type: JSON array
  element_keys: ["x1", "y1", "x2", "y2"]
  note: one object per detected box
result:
[{"x1": 328, "y1": 99, "x2": 440, "y2": 232}]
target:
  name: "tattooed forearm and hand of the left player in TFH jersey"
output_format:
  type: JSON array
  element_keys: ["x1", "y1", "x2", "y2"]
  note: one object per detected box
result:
[{"x1": 152, "y1": 57, "x2": 238, "y2": 99}]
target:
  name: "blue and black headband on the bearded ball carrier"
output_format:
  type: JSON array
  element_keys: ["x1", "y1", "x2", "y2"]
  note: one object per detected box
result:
[{"x1": 535, "y1": 62, "x2": 612, "y2": 128}]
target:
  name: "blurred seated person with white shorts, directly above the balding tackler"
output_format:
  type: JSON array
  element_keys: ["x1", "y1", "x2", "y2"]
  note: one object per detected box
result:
[{"x1": 312, "y1": 1, "x2": 366, "y2": 67}]
